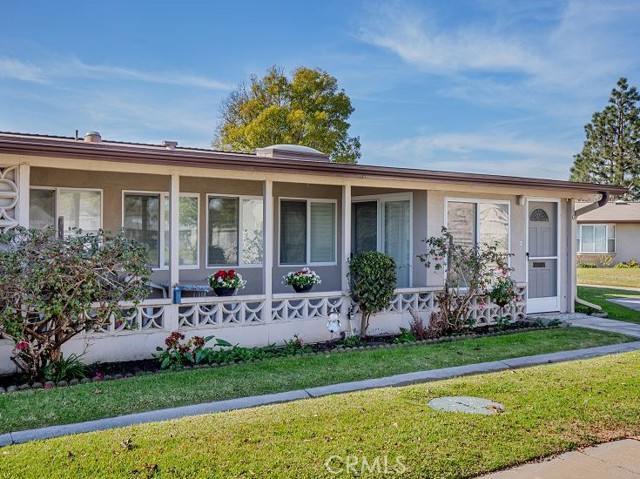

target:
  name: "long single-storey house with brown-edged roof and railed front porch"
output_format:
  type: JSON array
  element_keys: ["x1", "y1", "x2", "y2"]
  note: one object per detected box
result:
[{"x1": 0, "y1": 132, "x2": 626, "y2": 371}]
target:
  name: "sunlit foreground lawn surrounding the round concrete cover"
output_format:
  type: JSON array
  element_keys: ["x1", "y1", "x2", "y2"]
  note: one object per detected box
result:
[{"x1": 0, "y1": 352, "x2": 640, "y2": 478}]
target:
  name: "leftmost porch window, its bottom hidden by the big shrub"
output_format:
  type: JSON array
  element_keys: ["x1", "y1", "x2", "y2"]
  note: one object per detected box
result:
[{"x1": 29, "y1": 188, "x2": 102, "y2": 235}]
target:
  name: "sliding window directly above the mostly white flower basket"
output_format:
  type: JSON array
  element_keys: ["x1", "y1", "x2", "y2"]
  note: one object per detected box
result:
[{"x1": 280, "y1": 200, "x2": 336, "y2": 265}]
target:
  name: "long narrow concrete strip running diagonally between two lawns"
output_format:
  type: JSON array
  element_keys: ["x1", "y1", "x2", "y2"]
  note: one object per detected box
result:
[{"x1": 0, "y1": 340, "x2": 640, "y2": 447}]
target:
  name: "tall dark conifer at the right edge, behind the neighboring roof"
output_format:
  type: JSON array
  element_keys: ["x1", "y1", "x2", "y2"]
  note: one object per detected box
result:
[{"x1": 570, "y1": 78, "x2": 640, "y2": 200}]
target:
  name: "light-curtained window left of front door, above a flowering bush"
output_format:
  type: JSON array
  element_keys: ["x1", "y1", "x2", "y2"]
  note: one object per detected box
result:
[{"x1": 447, "y1": 200, "x2": 509, "y2": 252}]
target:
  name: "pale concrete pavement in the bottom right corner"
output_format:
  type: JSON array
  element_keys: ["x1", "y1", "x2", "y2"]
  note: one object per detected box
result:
[{"x1": 478, "y1": 439, "x2": 640, "y2": 479}]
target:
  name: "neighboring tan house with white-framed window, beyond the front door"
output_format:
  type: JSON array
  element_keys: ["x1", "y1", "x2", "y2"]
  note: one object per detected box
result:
[{"x1": 576, "y1": 201, "x2": 640, "y2": 266}]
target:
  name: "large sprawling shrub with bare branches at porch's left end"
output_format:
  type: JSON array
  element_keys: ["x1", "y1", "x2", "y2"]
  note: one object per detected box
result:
[{"x1": 0, "y1": 228, "x2": 151, "y2": 380}]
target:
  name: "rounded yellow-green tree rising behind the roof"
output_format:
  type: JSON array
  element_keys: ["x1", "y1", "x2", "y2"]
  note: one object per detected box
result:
[{"x1": 213, "y1": 66, "x2": 360, "y2": 163}]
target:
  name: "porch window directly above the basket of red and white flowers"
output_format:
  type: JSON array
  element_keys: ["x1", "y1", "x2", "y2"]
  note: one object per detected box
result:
[{"x1": 207, "y1": 196, "x2": 264, "y2": 267}]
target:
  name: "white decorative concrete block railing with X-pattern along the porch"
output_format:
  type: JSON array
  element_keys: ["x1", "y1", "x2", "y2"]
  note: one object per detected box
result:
[{"x1": 99, "y1": 283, "x2": 526, "y2": 333}]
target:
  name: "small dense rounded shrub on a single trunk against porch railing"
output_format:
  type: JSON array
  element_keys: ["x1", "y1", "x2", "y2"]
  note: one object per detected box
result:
[{"x1": 349, "y1": 251, "x2": 397, "y2": 338}]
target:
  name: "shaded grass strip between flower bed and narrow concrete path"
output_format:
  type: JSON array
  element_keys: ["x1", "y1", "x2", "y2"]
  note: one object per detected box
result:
[{"x1": 0, "y1": 328, "x2": 631, "y2": 433}]
